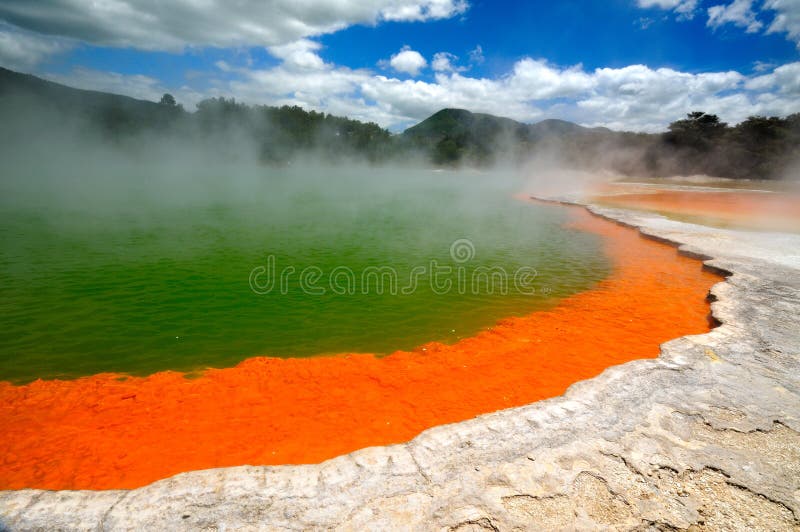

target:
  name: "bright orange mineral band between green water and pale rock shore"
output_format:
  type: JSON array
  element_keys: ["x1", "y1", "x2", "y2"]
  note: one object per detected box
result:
[{"x1": 0, "y1": 207, "x2": 721, "y2": 489}]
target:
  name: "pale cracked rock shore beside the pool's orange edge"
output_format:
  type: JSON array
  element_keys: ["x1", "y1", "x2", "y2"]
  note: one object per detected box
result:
[{"x1": 0, "y1": 198, "x2": 800, "y2": 531}]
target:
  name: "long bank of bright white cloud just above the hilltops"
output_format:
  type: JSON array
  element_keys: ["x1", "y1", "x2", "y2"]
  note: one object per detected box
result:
[{"x1": 205, "y1": 48, "x2": 800, "y2": 131}]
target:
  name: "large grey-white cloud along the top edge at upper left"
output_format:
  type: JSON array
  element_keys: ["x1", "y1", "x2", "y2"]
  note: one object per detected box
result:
[{"x1": 0, "y1": 0, "x2": 469, "y2": 51}]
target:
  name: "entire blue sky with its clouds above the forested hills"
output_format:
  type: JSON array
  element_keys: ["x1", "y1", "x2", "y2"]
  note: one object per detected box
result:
[{"x1": 0, "y1": 0, "x2": 800, "y2": 131}]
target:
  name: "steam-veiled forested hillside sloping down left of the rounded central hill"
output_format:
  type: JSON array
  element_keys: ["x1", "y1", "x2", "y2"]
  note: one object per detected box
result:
[{"x1": 0, "y1": 68, "x2": 393, "y2": 164}]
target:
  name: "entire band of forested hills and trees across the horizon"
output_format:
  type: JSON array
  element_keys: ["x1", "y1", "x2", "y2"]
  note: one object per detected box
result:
[{"x1": 0, "y1": 68, "x2": 800, "y2": 179}]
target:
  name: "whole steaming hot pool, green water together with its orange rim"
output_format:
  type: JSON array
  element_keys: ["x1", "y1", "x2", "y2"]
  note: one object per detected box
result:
[{"x1": 0, "y1": 163, "x2": 719, "y2": 489}]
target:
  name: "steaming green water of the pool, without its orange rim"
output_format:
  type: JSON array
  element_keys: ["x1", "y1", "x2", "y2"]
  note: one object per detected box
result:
[{"x1": 0, "y1": 166, "x2": 609, "y2": 384}]
